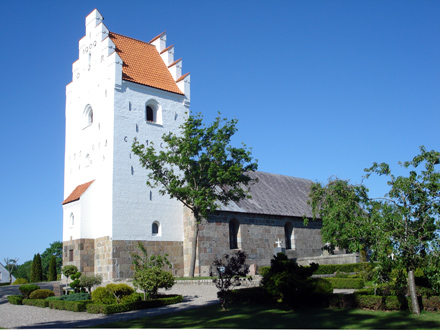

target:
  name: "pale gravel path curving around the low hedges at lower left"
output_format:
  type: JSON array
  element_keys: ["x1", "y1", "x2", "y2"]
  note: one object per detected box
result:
[{"x1": 0, "y1": 284, "x2": 218, "y2": 329}]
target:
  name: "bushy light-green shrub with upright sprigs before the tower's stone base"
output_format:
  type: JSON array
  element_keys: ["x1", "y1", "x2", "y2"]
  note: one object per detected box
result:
[{"x1": 131, "y1": 242, "x2": 175, "y2": 300}]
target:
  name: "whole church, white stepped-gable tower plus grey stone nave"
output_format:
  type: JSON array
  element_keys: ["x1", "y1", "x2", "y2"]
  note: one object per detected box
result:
[{"x1": 62, "y1": 9, "x2": 352, "y2": 280}]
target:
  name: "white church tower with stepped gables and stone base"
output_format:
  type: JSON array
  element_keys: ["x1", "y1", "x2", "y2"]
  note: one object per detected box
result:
[{"x1": 63, "y1": 9, "x2": 190, "y2": 280}]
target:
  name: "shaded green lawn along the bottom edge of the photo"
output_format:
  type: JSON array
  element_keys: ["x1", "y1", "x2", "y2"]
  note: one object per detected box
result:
[{"x1": 94, "y1": 304, "x2": 440, "y2": 329}]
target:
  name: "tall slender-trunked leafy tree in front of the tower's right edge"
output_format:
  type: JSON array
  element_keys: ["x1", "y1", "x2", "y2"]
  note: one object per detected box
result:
[{"x1": 132, "y1": 114, "x2": 257, "y2": 277}]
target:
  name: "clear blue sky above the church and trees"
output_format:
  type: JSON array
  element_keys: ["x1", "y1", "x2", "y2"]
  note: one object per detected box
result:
[{"x1": 0, "y1": 0, "x2": 440, "y2": 264}]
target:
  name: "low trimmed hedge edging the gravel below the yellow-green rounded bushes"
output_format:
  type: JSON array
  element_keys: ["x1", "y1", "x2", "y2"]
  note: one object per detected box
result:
[{"x1": 87, "y1": 295, "x2": 183, "y2": 314}]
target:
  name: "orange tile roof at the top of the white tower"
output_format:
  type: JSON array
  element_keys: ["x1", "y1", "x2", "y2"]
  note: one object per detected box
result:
[{"x1": 109, "y1": 32, "x2": 183, "y2": 95}]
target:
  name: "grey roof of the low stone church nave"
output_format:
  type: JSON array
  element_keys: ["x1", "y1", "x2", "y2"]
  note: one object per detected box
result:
[{"x1": 218, "y1": 171, "x2": 313, "y2": 218}]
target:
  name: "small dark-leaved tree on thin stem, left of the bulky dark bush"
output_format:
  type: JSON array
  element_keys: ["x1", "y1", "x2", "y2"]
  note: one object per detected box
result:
[{"x1": 210, "y1": 251, "x2": 250, "y2": 310}]
